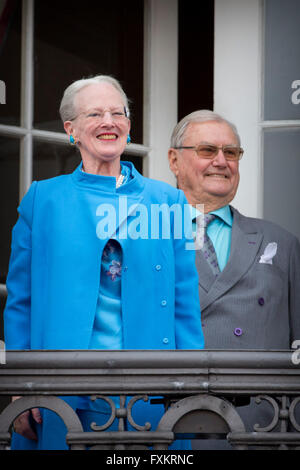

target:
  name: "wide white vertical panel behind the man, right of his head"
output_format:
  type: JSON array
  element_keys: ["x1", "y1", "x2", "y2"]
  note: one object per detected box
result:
[{"x1": 214, "y1": 0, "x2": 263, "y2": 217}]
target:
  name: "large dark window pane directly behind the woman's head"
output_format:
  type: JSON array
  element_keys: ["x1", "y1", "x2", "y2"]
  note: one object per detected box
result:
[{"x1": 34, "y1": 0, "x2": 144, "y2": 143}]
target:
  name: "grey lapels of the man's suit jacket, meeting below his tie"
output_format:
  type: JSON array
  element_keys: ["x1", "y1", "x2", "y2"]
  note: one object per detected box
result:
[{"x1": 196, "y1": 208, "x2": 263, "y2": 311}]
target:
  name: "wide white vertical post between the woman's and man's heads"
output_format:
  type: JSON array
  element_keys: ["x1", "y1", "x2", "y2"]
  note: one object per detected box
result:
[{"x1": 144, "y1": 0, "x2": 178, "y2": 185}]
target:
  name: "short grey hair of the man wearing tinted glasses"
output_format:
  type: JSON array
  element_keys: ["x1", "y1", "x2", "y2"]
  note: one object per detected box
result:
[{"x1": 171, "y1": 109, "x2": 241, "y2": 148}]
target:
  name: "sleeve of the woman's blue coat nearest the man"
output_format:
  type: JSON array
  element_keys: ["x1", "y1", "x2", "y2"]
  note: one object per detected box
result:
[{"x1": 174, "y1": 191, "x2": 204, "y2": 349}]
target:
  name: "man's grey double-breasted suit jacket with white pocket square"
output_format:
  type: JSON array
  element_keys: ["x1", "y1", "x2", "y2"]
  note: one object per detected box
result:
[{"x1": 196, "y1": 208, "x2": 300, "y2": 349}]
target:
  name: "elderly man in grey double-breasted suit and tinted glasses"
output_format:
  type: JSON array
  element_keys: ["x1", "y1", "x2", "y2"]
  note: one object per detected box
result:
[{"x1": 168, "y1": 110, "x2": 300, "y2": 448}]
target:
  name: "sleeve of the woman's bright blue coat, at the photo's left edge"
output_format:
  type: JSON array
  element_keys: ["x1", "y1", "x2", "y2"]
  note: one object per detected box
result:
[{"x1": 4, "y1": 182, "x2": 36, "y2": 349}]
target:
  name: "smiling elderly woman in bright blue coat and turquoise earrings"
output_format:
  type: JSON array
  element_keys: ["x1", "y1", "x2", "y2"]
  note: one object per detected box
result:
[{"x1": 5, "y1": 75, "x2": 204, "y2": 449}]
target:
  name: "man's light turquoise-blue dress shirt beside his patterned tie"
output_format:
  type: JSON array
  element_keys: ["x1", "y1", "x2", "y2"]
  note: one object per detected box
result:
[{"x1": 191, "y1": 205, "x2": 233, "y2": 271}]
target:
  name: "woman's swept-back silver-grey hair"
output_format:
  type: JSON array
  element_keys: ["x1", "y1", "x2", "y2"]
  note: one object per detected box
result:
[{"x1": 59, "y1": 75, "x2": 129, "y2": 122}]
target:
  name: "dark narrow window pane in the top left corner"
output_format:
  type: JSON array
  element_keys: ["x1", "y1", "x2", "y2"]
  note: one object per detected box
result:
[{"x1": 0, "y1": 0, "x2": 21, "y2": 126}]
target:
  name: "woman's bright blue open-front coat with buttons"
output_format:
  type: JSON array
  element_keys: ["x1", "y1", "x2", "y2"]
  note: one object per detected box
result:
[{"x1": 4, "y1": 162, "x2": 204, "y2": 448}]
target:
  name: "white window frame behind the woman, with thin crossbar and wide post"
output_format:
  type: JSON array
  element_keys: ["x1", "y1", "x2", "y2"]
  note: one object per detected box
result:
[{"x1": 0, "y1": 0, "x2": 178, "y2": 295}]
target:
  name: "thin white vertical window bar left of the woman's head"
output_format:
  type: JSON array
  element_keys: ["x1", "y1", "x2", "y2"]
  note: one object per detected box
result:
[{"x1": 19, "y1": 0, "x2": 34, "y2": 199}]
